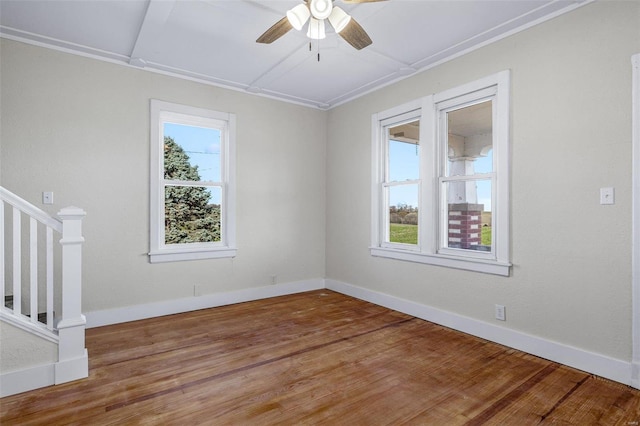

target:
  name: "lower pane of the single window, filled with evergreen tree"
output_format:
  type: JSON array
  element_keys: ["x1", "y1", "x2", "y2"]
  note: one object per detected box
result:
[{"x1": 164, "y1": 186, "x2": 221, "y2": 244}]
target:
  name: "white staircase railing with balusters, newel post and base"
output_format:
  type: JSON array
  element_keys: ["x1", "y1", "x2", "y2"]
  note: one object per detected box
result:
[{"x1": 0, "y1": 187, "x2": 88, "y2": 397}]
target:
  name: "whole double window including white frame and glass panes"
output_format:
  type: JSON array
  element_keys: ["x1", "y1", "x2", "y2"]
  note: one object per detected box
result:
[{"x1": 371, "y1": 71, "x2": 511, "y2": 276}]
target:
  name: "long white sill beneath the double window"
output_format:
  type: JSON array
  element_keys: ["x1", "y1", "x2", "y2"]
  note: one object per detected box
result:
[{"x1": 370, "y1": 247, "x2": 511, "y2": 277}]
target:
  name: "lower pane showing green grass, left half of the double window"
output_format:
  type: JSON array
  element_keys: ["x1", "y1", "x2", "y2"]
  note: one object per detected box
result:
[{"x1": 388, "y1": 184, "x2": 418, "y2": 244}]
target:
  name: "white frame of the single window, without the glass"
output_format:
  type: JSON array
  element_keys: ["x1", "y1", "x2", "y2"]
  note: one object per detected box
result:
[{"x1": 149, "y1": 99, "x2": 237, "y2": 263}]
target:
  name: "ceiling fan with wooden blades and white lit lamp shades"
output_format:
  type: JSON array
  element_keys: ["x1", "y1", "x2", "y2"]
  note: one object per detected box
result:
[{"x1": 256, "y1": 0, "x2": 384, "y2": 50}]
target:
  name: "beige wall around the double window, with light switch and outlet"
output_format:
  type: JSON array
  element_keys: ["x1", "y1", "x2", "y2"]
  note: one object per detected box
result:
[{"x1": 326, "y1": 2, "x2": 640, "y2": 361}]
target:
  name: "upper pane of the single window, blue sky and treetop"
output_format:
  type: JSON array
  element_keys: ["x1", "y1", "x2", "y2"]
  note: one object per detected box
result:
[{"x1": 164, "y1": 123, "x2": 222, "y2": 182}]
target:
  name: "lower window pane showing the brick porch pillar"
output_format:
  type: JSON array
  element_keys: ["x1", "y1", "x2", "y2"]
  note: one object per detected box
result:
[{"x1": 444, "y1": 179, "x2": 493, "y2": 251}]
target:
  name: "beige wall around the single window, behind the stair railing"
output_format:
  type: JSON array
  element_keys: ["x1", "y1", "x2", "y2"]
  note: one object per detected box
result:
[{"x1": 0, "y1": 39, "x2": 326, "y2": 312}]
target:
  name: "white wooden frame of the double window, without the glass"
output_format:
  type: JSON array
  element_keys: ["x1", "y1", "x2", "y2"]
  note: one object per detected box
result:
[{"x1": 370, "y1": 70, "x2": 511, "y2": 276}]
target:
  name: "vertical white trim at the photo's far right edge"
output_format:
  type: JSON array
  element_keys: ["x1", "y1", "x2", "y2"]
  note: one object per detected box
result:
[{"x1": 631, "y1": 53, "x2": 640, "y2": 389}]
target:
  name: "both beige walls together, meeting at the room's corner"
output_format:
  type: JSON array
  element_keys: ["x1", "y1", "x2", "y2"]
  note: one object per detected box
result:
[{"x1": 0, "y1": 2, "x2": 640, "y2": 372}]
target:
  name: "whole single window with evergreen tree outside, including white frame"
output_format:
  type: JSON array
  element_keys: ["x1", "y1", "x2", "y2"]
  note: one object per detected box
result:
[{"x1": 149, "y1": 100, "x2": 236, "y2": 263}]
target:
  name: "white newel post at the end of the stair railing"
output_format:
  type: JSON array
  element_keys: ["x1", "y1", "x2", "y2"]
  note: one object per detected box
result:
[{"x1": 55, "y1": 207, "x2": 89, "y2": 384}]
